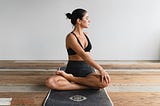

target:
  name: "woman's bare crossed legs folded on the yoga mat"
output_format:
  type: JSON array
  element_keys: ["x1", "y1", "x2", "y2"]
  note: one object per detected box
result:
[{"x1": 46, "y1": 71, "x2": 108, "y2": 90}]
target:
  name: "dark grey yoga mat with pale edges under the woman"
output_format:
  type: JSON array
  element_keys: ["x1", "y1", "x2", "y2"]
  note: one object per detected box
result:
[{"x1": 43, "y1": 89, "x2": 113, "y2": 106}]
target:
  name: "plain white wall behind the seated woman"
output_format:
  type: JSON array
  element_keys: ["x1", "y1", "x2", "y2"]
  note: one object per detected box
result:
[{"x1": 0, "y1": 0, "x2": 160, "y2": 60}]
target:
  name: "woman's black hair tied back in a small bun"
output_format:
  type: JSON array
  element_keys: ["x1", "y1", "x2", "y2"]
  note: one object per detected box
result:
[{"x1": 66, "y1": 8, "x2": 87, "y2": 26}]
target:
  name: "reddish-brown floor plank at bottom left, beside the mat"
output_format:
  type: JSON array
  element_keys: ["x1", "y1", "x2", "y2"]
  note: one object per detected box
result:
[{"x1": 0, "y1": 91, "x2": 48, "y2": 106}]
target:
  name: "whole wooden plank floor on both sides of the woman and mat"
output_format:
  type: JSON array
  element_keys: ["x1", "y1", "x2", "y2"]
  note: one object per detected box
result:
[{"x1": 0, "y1": 60, "x2": 160, "y2": 106}]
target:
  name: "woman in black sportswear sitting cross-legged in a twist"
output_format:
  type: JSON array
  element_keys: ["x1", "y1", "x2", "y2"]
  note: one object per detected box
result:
[{"x1": 46, "y1": 9, "x2": 110, "y2": 90}]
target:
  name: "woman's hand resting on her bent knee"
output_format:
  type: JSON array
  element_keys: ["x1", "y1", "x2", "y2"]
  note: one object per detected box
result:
[{"x1": 100, "y1": 69, "x2": 111, "y2": 84}]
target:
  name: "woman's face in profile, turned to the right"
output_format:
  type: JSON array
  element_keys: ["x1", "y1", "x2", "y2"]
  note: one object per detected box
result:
[{"x1": 80, "y1": 13, "x2": 90, "y2": 28}]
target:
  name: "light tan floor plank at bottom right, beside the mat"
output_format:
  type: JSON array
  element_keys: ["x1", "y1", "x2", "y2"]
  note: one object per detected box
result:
[{"x1": 109, "y1": 92, "x2": 160, "y2": 106}]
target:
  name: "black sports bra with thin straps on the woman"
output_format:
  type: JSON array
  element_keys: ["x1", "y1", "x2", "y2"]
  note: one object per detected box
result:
[{"x1": 67, "y1": 32, "x2": 92, "y2": 55}]
